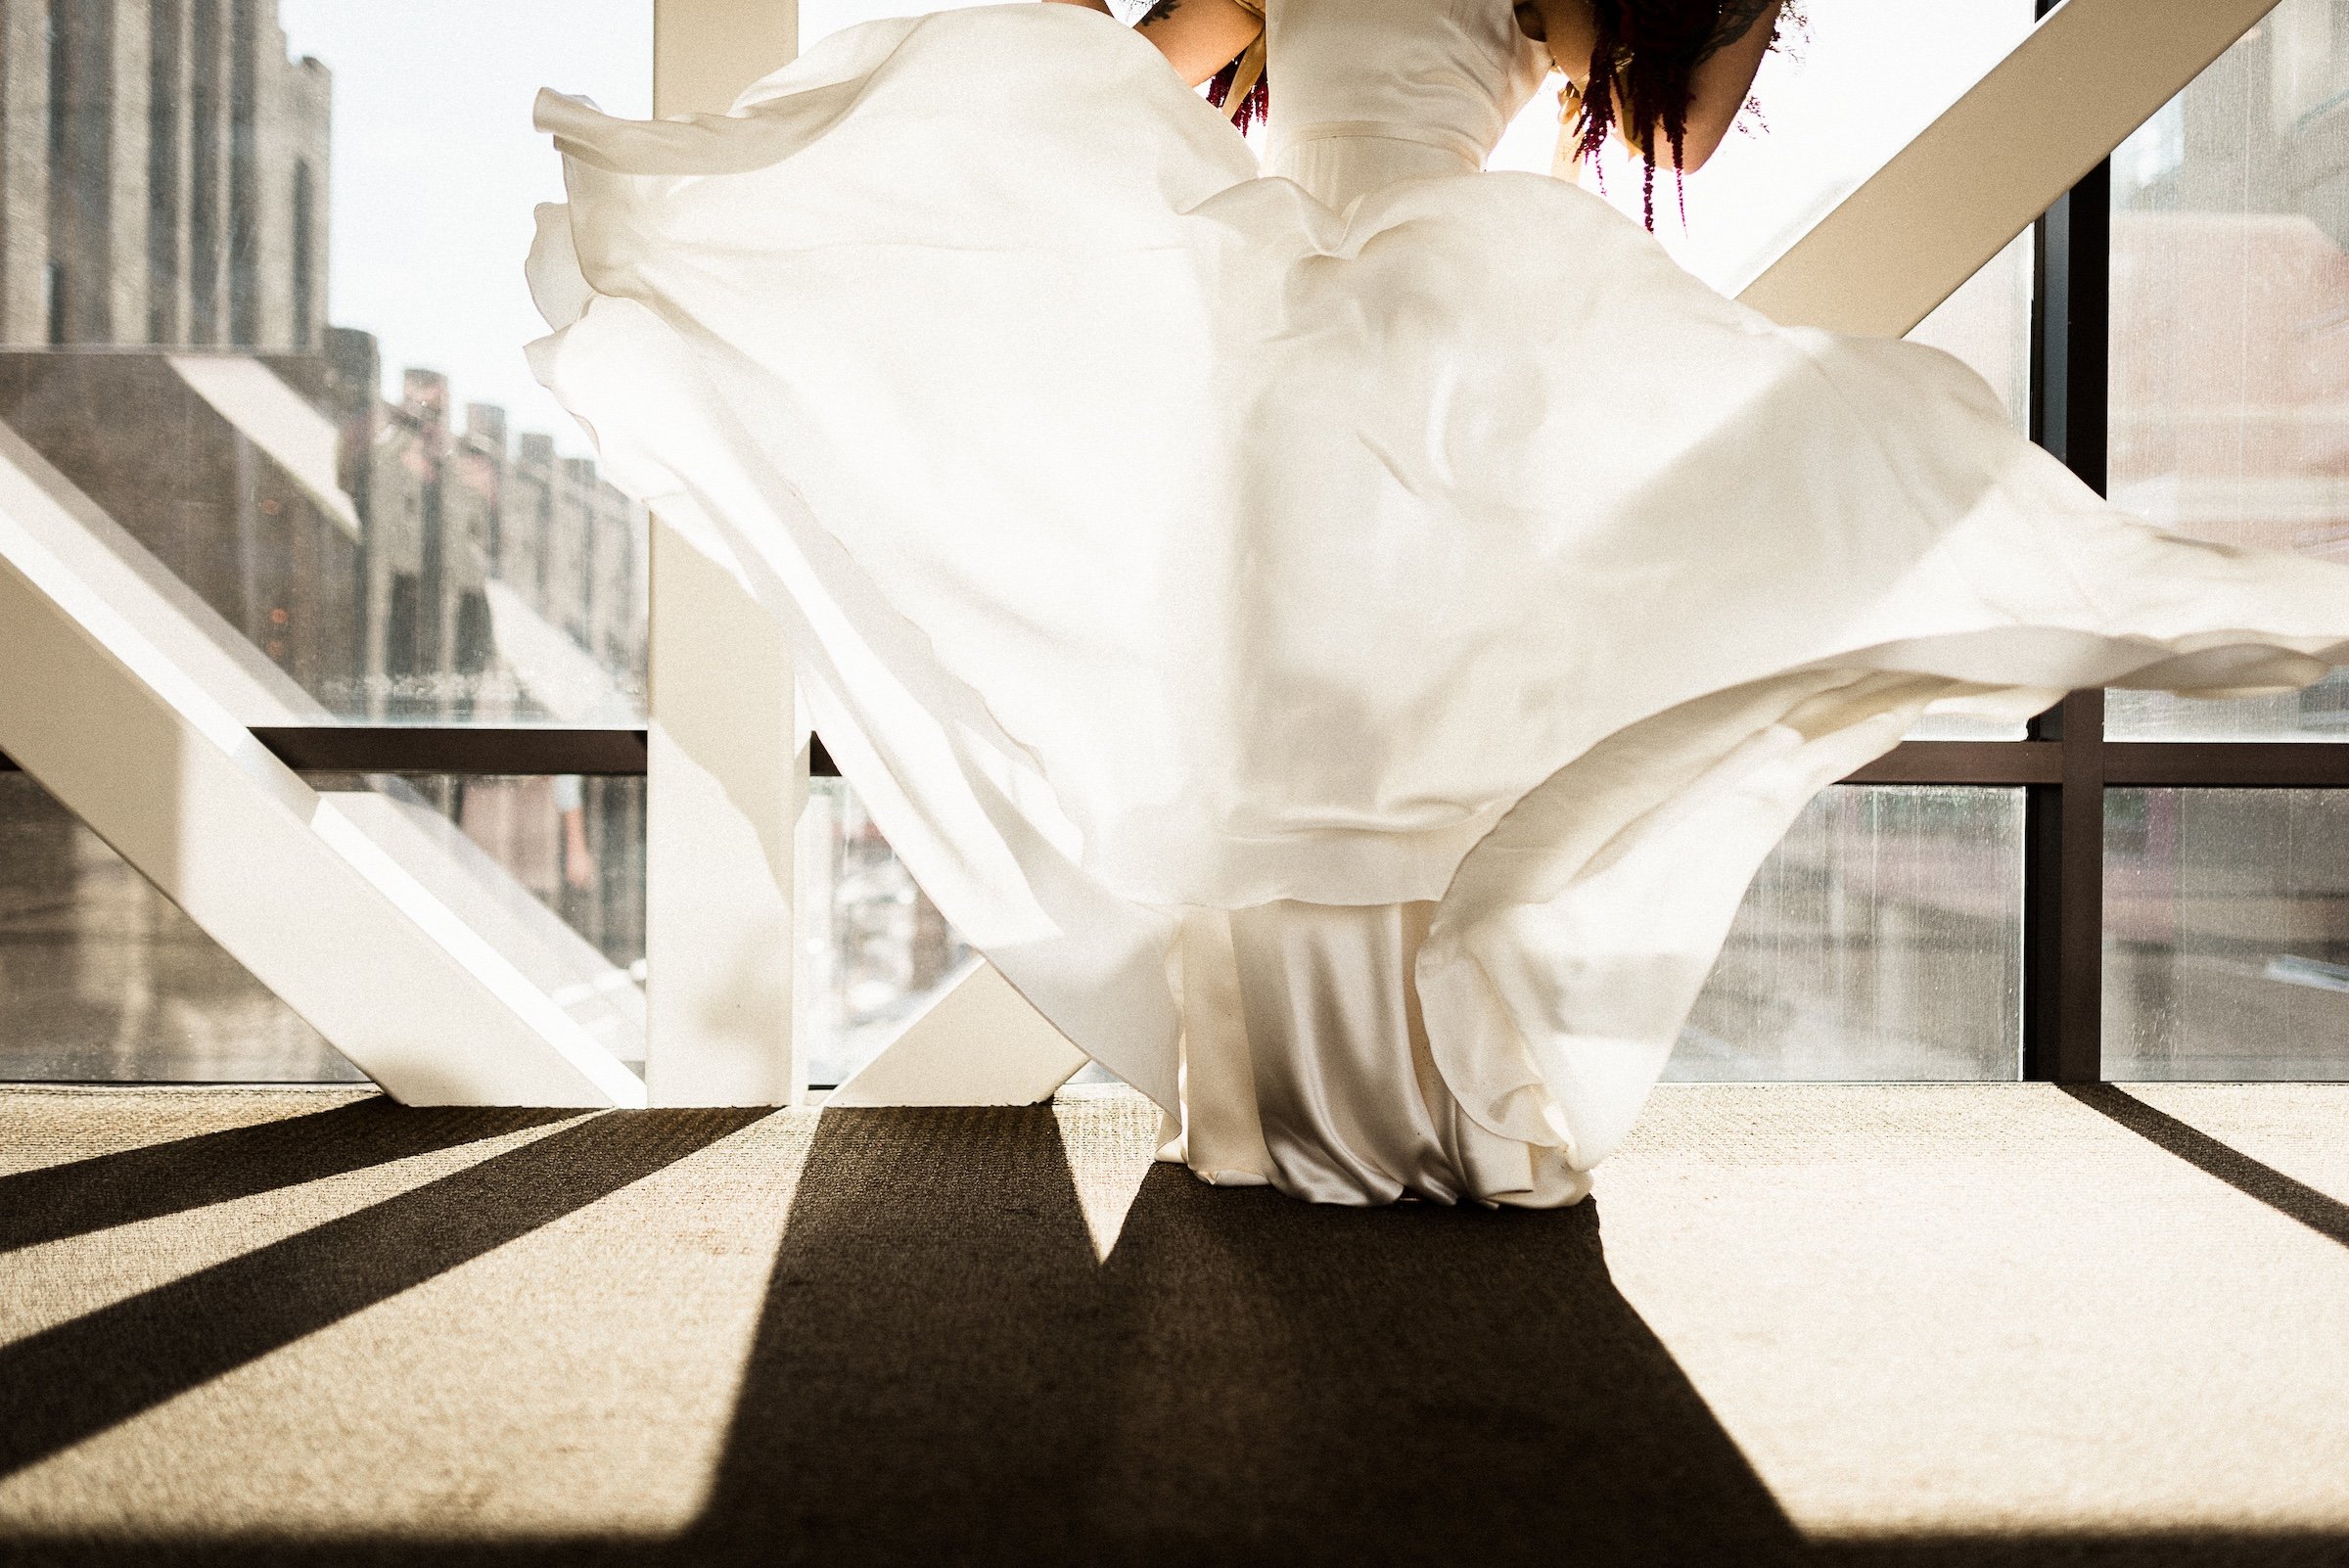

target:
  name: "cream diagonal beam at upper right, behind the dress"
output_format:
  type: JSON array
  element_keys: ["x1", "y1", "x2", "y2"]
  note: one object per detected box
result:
[{"x1": 1738, "y1": 0, "x2": 2277, "y2": 338}]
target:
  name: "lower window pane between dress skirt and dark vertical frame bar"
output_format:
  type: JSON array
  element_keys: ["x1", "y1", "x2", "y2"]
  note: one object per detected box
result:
[{"x1": 1666, "y1": 786, "x2": 2022, "y2": 1083}]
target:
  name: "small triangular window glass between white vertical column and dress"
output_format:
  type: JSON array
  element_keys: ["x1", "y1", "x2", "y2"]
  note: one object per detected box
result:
[{"x1": 797, "y1": 779, "x2": 977, "y2": 1086}]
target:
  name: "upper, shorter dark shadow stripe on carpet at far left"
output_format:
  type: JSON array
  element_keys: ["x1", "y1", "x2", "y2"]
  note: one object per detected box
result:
[{"x1": 0, "y1": 1098, "x2": 580, "y2": 1251}]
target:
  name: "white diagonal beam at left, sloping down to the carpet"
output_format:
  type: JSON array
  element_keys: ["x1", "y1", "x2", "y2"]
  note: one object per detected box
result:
[{"x1": 0, "y1": 427, "x2": 644, "y2": 1106}]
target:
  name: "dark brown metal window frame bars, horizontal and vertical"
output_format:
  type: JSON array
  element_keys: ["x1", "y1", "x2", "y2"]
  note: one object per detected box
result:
[{"x1": 0, "y1": 140, "x2": 2349, "y2": 1083}]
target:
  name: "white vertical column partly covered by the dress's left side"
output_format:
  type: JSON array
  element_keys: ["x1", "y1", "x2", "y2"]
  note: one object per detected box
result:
[{"x1": 646, "y1": 0, "x2": 808, "y2": 1106}]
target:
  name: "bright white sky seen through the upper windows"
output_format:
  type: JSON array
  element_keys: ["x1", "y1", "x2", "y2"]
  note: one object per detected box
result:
[{"x1": 277, "y1": 0, "x2": 2032, "y2": 453}]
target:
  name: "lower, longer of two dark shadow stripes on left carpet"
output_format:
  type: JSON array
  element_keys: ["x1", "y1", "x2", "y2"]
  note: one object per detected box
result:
[{"x1": 0, "y1": 1110, "x2": 761, "y2": 1476}]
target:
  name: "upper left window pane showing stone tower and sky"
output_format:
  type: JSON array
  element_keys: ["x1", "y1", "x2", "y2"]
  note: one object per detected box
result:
[{"x1": 0, "y1": 0, "x2": 651, "y2": 725}]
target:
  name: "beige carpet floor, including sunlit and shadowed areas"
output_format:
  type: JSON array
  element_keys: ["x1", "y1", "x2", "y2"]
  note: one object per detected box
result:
[{"x1": 0, "y1": 1084, "x2": 2349, "y2": 1568}]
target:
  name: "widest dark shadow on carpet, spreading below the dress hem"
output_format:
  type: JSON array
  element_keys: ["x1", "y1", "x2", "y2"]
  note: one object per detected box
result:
[{"x1": 693, "y1": 1108, "x2": 1797, "y2": 1563}]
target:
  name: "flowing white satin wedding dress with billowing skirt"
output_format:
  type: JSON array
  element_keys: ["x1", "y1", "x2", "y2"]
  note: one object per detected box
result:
[{"x1": 530, "y1": 0, "x2": 2349, "y2": 1204}]
